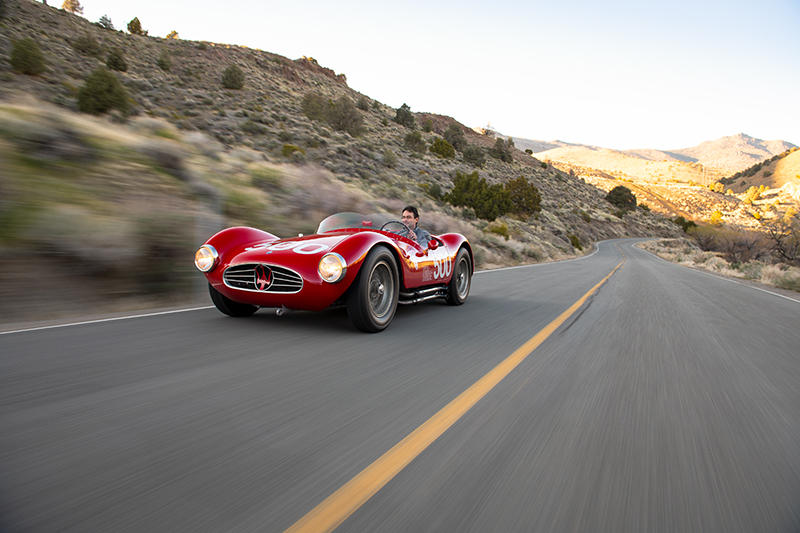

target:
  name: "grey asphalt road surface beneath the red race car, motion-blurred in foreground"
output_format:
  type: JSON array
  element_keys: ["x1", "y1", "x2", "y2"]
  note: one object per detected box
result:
[{"x1": 0, "y1": 241, "x2": 800, "y2": 532}]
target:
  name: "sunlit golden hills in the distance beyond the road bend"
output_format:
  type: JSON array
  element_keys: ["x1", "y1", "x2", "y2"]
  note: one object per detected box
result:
[{"x1": 498, "y1": 133, "x2": 800, "y2": 230}]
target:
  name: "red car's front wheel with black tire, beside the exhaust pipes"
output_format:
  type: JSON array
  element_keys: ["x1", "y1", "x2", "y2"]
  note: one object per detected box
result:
[{"x1": 347, "y1": 246, "x2": 400, "y2": 333}]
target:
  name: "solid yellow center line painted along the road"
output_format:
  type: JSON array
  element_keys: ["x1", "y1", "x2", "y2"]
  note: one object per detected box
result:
[{"x1": 286, "y1": 259, "x2": 625, "y2": 533}]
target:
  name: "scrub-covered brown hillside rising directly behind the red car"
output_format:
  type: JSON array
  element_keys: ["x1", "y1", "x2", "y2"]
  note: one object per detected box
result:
[{"x1": 0, "y1": 0, "x2": 677, "y2": 320}]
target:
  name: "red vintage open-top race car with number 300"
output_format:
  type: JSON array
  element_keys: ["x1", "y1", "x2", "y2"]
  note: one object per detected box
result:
[{"x1": 195, "y1": 213, "x2": 474, "y2": 332}]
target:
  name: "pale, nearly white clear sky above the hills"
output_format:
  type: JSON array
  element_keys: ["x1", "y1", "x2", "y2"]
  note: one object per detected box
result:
[{"x1": 79, "y1": 0, "x2": 800, "y2": 149}]
